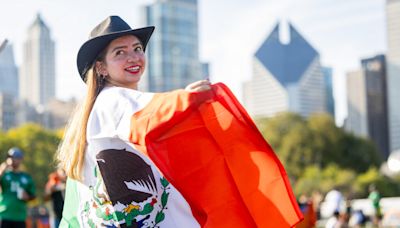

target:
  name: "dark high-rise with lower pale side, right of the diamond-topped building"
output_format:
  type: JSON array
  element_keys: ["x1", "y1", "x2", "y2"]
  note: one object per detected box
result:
[{"x1": 345, "y1": 55, "x2": 389, "y2": 158}]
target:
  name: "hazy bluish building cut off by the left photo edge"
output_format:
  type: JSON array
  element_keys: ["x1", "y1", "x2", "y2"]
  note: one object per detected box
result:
[{"x1": 0, "y1": 40, "x2": 18, "y2": 99}]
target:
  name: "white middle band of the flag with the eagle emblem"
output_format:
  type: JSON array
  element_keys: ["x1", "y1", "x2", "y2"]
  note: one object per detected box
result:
[{"x1": 71, "y1": 87, "x2": 200, "y2": 228}]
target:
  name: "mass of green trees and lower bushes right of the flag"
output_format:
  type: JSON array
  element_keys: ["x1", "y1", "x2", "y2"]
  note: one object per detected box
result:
[{"x1": 256, "y1": 113, "x2": 400, "y2": 197}]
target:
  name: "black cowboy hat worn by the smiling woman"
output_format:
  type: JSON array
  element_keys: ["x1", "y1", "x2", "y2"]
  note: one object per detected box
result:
[{"x1": 77, "y1": 16, "x2": 154, "y2": 81}]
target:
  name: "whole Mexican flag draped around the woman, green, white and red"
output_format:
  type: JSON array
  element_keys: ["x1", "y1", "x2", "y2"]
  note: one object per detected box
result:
[{"x1": 61, "y1": 84, "x2": 303, "y2": 228}]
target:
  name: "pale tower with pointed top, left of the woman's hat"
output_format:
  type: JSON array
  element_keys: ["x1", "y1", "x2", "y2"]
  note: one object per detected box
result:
[{"x1": 20, "y1": 14, "x2": 55, "y2": 106}]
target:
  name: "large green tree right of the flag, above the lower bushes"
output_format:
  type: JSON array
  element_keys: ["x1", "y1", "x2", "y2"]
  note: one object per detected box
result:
[{"x1": 256, "y1": 113, "x2": 382, "y2": 180}]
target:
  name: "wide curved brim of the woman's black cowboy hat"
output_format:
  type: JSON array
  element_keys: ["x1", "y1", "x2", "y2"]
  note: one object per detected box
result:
[{"x1": 77, "y1": 26, "x2": 154, "y2": 81}]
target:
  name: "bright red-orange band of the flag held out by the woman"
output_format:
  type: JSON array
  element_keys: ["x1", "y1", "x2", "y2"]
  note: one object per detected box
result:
[{"x1": 131, "y1": 83, "x2": 302, "y2": 227}]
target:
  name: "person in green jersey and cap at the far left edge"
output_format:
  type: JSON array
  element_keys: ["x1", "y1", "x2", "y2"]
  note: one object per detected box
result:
[{"x1": 0, "y1": 147, "x2": 35, "y2": 228}]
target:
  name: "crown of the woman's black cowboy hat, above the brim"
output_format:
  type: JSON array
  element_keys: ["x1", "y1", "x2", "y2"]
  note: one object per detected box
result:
[{"x1": 89, "y1": 16, "x2": 131, "y2": 39}]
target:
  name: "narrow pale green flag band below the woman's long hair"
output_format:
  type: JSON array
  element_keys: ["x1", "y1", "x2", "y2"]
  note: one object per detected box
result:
[{"x1": 60, "y1": 178, "x2": 79, "y2": 228}]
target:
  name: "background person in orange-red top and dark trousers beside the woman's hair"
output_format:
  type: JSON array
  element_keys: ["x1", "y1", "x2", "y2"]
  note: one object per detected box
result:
[{"x1": 45, "y1": 168, "x2": 67, "y2": 227}]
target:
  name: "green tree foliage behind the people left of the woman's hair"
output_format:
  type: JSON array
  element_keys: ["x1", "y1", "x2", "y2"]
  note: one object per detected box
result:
[{"x1": 0, "y1": 124, "x2": 60, "y2": 200}]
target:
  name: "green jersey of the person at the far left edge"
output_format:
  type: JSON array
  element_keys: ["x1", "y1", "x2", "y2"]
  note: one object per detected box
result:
[{"x1": 0, "y1": 171, "x2": 35, "y2": 221}]
